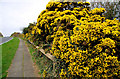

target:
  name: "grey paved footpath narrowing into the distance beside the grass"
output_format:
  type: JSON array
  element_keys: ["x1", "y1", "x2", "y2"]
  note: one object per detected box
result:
[{"x1": 8, "y1": 39, "x2": 36, "y2": 77}]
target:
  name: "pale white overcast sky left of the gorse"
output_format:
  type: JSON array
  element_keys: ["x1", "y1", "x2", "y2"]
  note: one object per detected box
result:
[{"x1": 0, "y1": 0, "x2": 49, "y2": 36}]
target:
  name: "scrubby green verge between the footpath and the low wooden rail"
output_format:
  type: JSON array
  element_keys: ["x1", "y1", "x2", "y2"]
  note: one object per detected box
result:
[{"x1": 26, "y1": 42, "x2": 53, "y2": 77}]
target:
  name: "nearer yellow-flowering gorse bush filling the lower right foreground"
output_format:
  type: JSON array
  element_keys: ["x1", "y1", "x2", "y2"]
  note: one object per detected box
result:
[{"x1": 52, "y1": 20, "x2": 120, "y2": 77}]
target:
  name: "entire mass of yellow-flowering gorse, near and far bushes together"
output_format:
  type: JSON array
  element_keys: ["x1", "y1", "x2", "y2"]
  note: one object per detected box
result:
[{"x1": 25, "y1": 2, "x2": 120, "y2": 78}]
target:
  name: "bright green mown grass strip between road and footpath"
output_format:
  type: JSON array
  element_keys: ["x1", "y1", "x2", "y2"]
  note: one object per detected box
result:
[{"x1": 0, "y1": 38, "x2": 19, "y2": 77}]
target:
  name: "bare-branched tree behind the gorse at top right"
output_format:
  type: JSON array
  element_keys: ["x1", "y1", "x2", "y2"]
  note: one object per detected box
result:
[{"x1": 90, "y1": 0, "x2": 120, "y2": 20}]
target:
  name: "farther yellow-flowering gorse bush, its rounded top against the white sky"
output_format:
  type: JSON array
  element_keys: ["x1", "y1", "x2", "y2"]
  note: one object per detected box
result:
[{"x1": 29, "y1": 2, "x2": 89, "y2": 41}]
